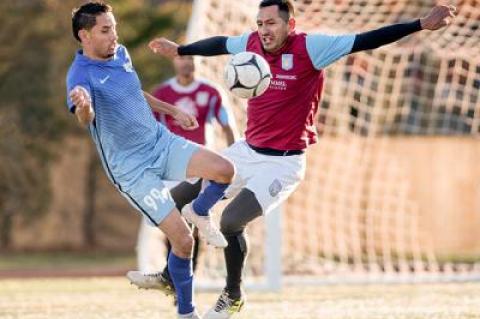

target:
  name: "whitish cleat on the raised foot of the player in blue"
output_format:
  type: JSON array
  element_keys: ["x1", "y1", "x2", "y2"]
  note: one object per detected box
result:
[{"x1": 182, "y1": 204, "x2": 228, "y2": 248}]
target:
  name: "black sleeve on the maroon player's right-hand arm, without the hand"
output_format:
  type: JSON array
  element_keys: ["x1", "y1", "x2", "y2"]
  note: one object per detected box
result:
[{"x1": 350, "y1": 20, "x2": 422, "y2": 53}]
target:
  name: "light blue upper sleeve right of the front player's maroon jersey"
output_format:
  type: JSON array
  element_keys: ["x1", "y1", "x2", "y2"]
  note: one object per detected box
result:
[{"x1": 306, "y1": 33, "x2": 355, "y2": 70}]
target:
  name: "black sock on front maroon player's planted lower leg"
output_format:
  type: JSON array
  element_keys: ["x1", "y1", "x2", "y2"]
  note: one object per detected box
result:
[{"x1": 224, "y1": 232, "x2": 248, "y2": 299}]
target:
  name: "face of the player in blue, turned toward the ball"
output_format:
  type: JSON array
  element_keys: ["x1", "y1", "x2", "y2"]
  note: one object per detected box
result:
[{"x1": 82, "y1": 12, "x2": 118, "y2": 60}]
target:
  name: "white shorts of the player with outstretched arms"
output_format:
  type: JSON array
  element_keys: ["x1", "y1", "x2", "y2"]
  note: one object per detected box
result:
[{"x1": 222, "y1": 140, "x2": 307, "y2": 214}]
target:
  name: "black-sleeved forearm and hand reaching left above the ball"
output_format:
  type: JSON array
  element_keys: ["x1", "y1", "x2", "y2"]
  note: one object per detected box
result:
[{"x1": 148, "y1": 36, "x2": 229, "y2": 59}]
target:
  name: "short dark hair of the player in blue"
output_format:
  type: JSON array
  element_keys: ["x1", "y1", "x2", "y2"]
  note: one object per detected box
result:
[{"x1": 72, "y1": 2, "x2": 112, "y2": 42}]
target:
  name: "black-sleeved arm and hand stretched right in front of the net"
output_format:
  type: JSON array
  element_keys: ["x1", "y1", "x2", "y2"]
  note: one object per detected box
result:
[{"x1": 350, "y1": 5, "x2": 456, "y2": 53}]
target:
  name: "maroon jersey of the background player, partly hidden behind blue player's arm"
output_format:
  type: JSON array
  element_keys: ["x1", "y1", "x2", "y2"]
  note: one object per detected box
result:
[{"x1": 153, "y1": 78, "x2": 222, "y2": 145}]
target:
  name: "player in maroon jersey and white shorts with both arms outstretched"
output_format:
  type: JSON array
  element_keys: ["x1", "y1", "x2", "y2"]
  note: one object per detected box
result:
[{"x1": 133, "y1": 0, "x2": 455, "y2": 319}]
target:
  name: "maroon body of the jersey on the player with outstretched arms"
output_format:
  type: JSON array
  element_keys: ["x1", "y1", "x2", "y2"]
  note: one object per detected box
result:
[{"x1": 245, "y1": 32, "x2": 324, "y2": 150}]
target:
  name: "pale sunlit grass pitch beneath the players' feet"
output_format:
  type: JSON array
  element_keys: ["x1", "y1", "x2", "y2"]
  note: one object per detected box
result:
[{"x1": 0, "y1": 277, "x2": 480, "y2": 319}]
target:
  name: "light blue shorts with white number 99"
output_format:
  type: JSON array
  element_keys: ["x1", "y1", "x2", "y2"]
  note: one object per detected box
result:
[{"x1": 121, "y1": 134, "x2": 200, "y2": 226}]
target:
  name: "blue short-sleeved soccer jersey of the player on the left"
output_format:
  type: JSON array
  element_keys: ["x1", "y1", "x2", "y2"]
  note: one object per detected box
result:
[{"x1": 67, "y1": 46, "x2": 168, "y2": 183}]
